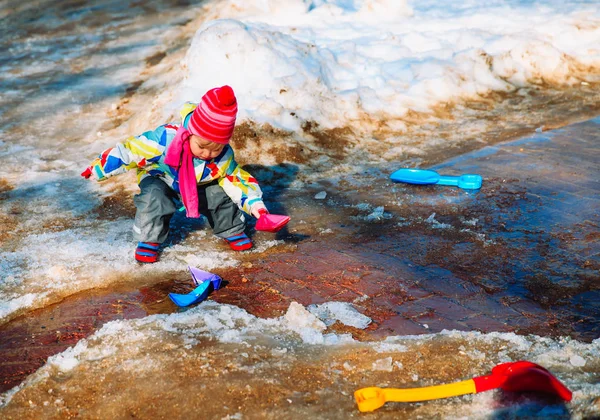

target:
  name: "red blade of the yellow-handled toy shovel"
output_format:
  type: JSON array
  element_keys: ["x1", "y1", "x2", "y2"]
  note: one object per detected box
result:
[{"x1": 473, "y1": 360, "x2": 573, "y2": 401}]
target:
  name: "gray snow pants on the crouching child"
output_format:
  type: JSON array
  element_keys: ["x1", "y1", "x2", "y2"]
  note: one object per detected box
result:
[{"x1": 133, "y1": 177, "x2": 246, "y2": 243}]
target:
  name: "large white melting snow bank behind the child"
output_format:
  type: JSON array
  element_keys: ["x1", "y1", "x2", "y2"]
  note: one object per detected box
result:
[{"x1": 176, "y1": 0, "x2": 600, "y2": 132}]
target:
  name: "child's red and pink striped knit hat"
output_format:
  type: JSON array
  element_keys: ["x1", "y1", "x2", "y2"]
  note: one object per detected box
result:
[{"x1": 188, "y1": 85, "x2": 237, "y2": 144}]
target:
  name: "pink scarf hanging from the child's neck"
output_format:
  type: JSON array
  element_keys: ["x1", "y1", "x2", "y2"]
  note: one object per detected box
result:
[{"x1": 165, "y1": 125, "x2": 200, "y2": 217}]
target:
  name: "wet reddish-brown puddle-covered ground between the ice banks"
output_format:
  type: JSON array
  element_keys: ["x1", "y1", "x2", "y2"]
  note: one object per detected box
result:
[{"x1": 0, "y1": 119, "x2": 600, "y2": 391}]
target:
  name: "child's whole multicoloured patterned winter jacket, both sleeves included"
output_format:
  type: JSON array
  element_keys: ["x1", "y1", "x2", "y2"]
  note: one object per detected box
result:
[{"x1": 91, "y1": 103, "x2": 263, "y2": 214}]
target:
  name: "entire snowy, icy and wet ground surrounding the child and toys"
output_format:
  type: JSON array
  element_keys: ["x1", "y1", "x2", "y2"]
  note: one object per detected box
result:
[{"x1": 0, "y1": 0, "x2": 600, "y2": 419}]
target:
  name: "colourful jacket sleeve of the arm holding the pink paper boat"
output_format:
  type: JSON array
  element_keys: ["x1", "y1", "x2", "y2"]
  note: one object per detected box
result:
[{"x1": 219, "y1": 153, "x2": 264, "y2": 215}]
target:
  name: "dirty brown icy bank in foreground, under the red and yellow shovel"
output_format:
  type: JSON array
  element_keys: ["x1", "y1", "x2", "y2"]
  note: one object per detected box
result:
[{"x1": 0, "y1": 302, "x2": 600, "y2": 419}]
